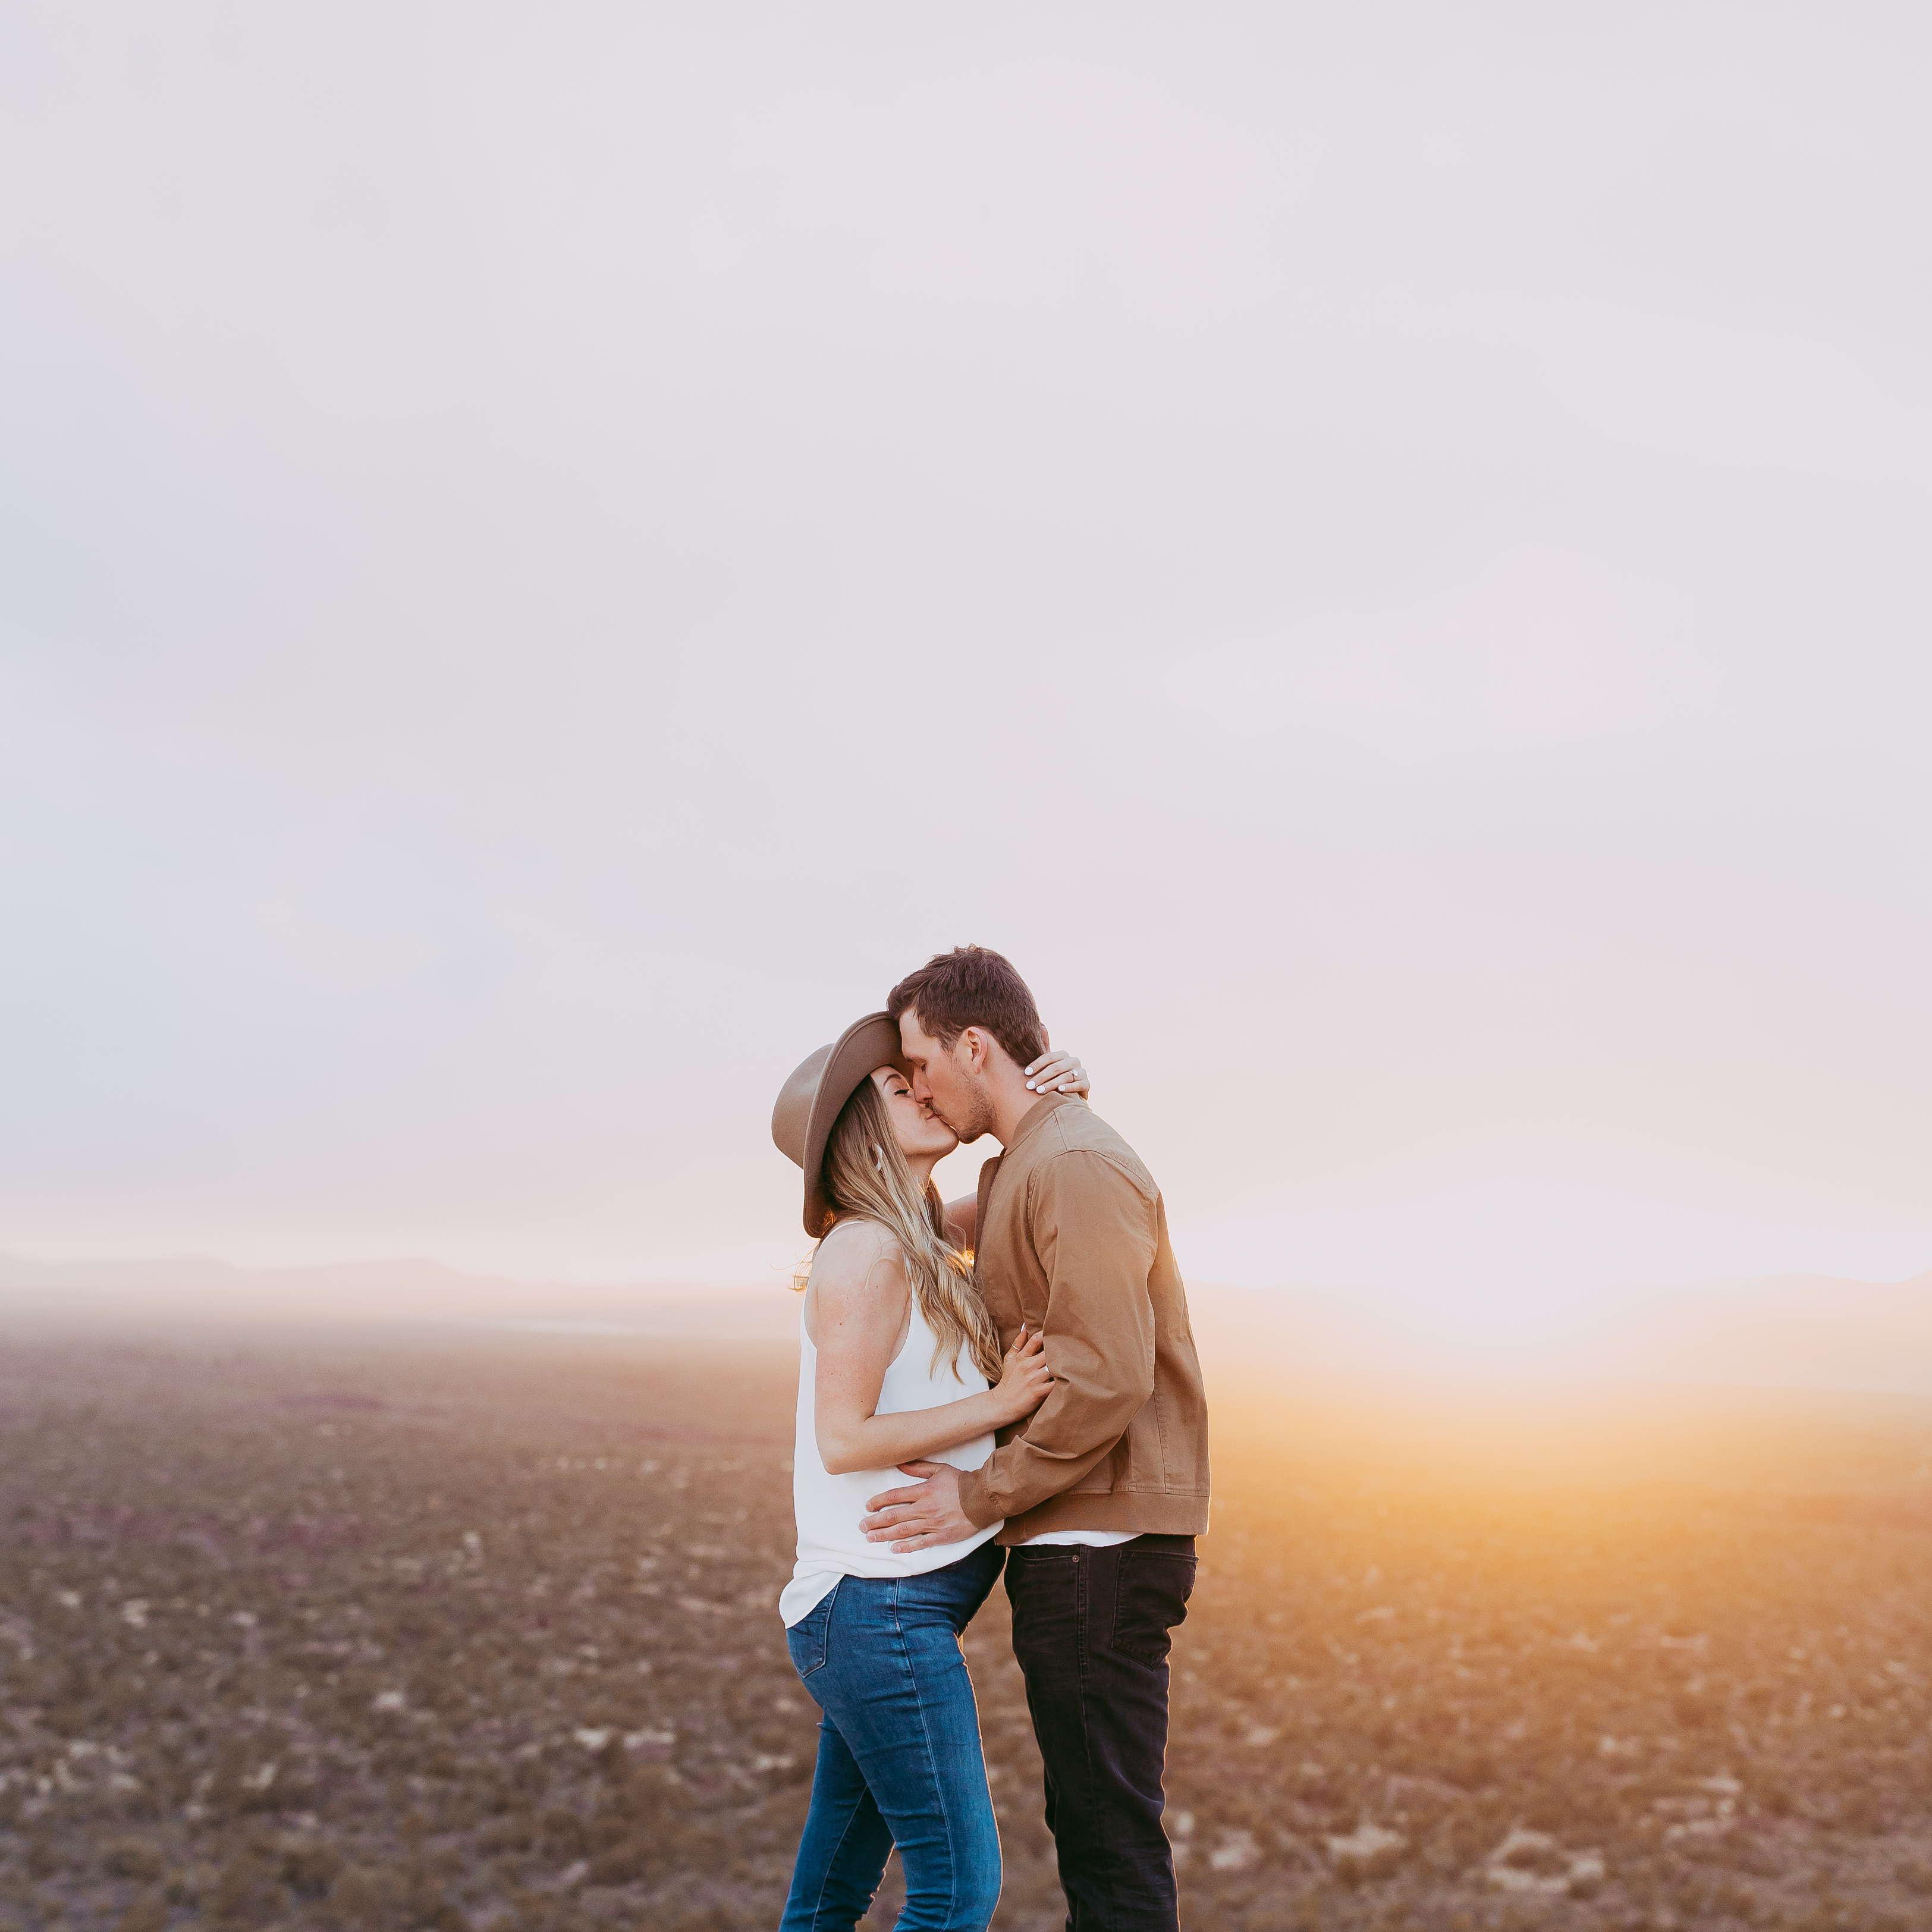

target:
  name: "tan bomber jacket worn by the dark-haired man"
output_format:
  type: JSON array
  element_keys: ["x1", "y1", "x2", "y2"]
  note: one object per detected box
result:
[{"x1": 960, "y1": 1094, "x2": 1208, "y2": 1544}]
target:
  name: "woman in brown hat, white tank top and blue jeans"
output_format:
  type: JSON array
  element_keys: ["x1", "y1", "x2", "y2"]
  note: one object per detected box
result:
[{"x1": 771, "y1": 1014, "x2": 1088, "y2": 1932}]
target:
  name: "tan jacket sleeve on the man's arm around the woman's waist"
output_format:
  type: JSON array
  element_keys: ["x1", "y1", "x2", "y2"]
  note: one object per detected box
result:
[{"x1": 960, "y1": 1148, "x2": 1155, "y2": 1528}]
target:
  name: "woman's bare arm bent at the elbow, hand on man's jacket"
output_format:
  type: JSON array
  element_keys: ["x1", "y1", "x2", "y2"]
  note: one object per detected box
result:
[{"x1": 808, "y1": 1223, "x2": 1049, "y2": 1476}]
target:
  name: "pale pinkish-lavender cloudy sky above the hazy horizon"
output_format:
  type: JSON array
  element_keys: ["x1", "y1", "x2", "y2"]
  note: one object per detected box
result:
[{"x1": 0, "y1": 0, "x2": 1932, "y2": 1352}]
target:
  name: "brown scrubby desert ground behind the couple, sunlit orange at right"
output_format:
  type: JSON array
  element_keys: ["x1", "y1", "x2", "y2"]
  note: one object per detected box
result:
[{"x1": 0, "y1": 1329, "x2": 1932, "y2": 1932}]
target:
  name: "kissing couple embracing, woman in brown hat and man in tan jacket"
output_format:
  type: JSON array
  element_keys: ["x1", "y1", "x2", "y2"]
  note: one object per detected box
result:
[{"x1": 771, "y1": 947, "x2": 1208, "y2": 1932}]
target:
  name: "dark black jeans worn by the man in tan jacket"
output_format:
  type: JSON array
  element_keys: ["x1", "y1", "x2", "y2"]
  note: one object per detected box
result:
[{"x1": 1007, "y1": 1536, "x2": 1194, "y2": 1932}]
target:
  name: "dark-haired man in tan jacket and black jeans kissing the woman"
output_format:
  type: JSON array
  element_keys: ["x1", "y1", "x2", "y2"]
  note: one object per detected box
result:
[{"x1": 863, "y1": 947, "x2": 1208, "y2": 1932}]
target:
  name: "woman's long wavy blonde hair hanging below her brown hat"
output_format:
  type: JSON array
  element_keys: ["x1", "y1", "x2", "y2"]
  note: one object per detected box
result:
[{"x1": 794, "y1": 1076, "x2": 1001, "y2": 1381}]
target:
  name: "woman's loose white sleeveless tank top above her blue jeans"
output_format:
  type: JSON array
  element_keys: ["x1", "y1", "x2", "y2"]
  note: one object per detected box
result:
[{"x1": 778, "y1": 1295, "x2": 999, "y2": 1627}]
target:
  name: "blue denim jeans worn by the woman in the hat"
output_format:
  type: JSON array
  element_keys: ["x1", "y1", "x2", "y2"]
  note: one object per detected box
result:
[{"x1": 781, "y1": 1544, "x2": 1004, "y2": 1932}]
